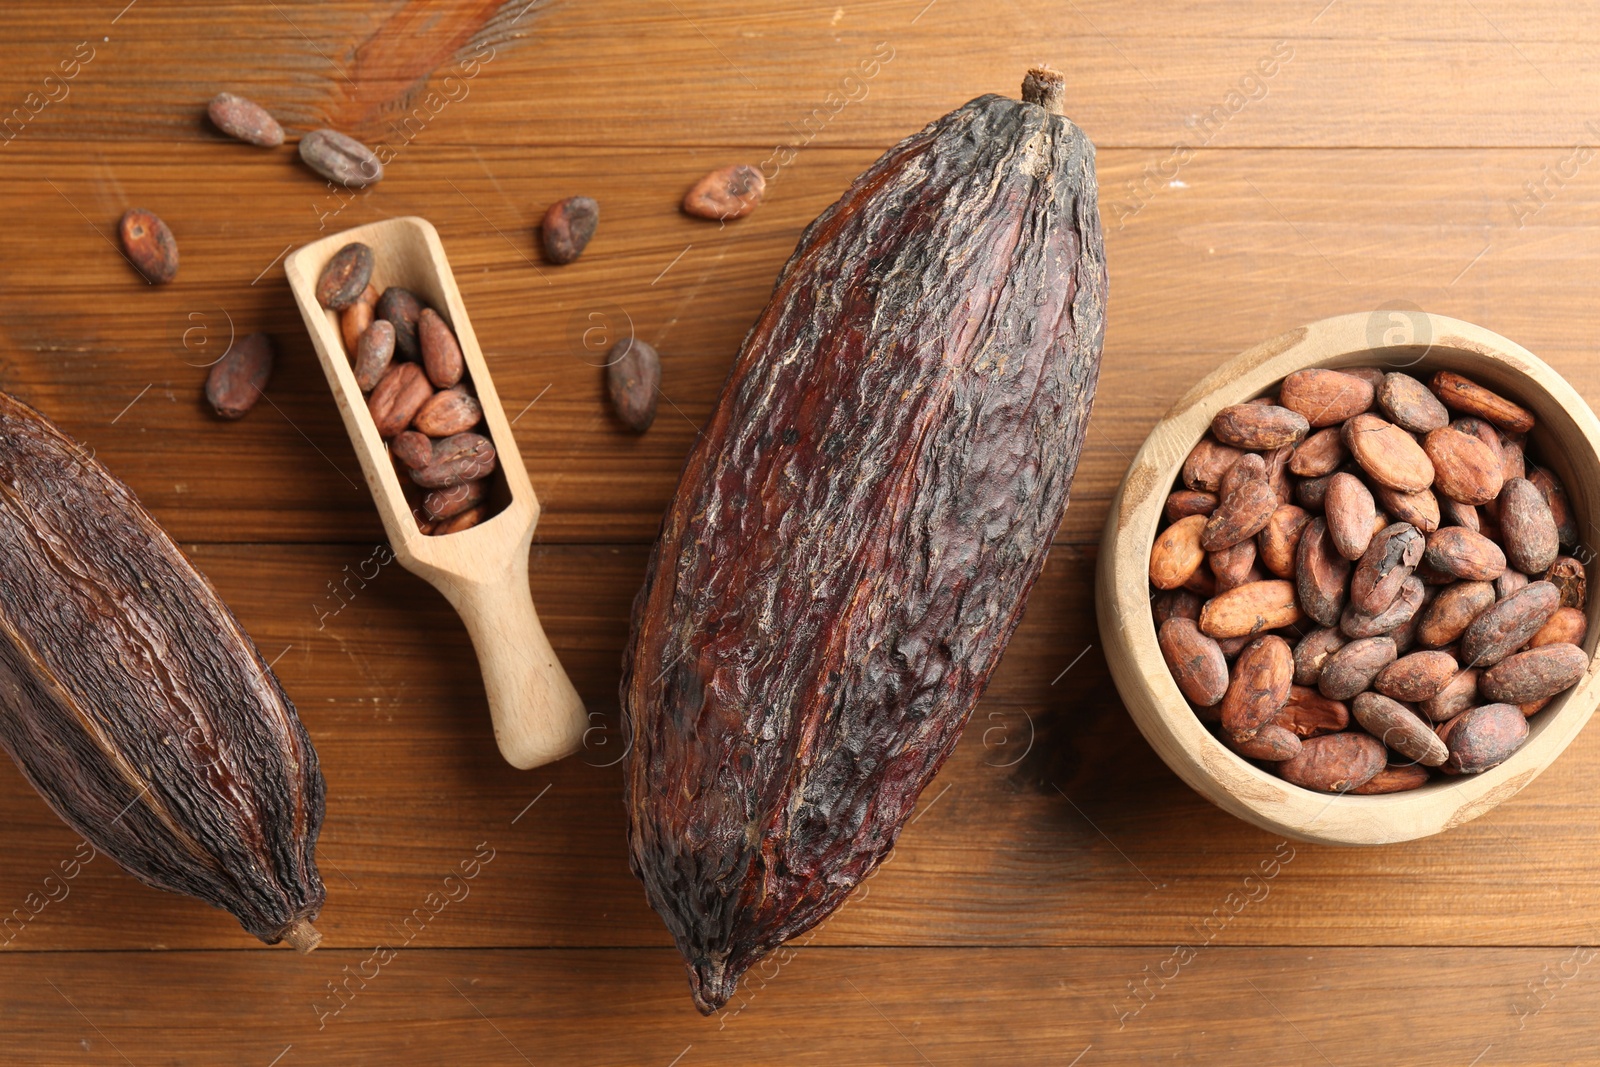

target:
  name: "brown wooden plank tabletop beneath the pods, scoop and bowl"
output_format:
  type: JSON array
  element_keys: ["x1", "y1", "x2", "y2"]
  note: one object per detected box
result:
[{"x1": 0, "y1": 0, "x2": 1600, "y2": 1067}]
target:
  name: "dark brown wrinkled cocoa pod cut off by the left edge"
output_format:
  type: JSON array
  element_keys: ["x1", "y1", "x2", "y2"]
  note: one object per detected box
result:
[{"x1": 0, "y1": 394, "x2": 323, "y2": 950}]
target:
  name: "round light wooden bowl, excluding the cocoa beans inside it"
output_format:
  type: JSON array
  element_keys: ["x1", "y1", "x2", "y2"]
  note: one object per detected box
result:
[{"x1": 1094, "y1": 312, "x2": 1600, "y2": 845}]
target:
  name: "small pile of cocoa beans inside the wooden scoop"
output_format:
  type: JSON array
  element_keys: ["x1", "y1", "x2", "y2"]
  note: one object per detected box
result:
[{"x1": 317, "y1": 242, "x2": 494, "y2": 536}]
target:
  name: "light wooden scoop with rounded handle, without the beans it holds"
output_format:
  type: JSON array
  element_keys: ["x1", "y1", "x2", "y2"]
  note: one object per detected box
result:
[{"x1": 283, "y1": 218, "x2": 587, "y2": 769}]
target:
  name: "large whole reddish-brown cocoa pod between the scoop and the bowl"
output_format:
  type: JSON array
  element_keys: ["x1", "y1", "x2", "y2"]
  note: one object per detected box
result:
[{"x1": 621, "y1": 70, "x2": 1106, "y2": 1014}]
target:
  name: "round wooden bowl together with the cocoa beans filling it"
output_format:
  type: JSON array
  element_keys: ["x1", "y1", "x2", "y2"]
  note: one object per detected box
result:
[{"x1": 1096, "y1": 314, "x2": 1600, "y2": 845}]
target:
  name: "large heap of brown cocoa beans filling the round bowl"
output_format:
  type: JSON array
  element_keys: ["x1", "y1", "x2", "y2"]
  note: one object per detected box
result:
[{"x1": 1150, "y1": 368, "x2": 1589, "y2": 793}]
